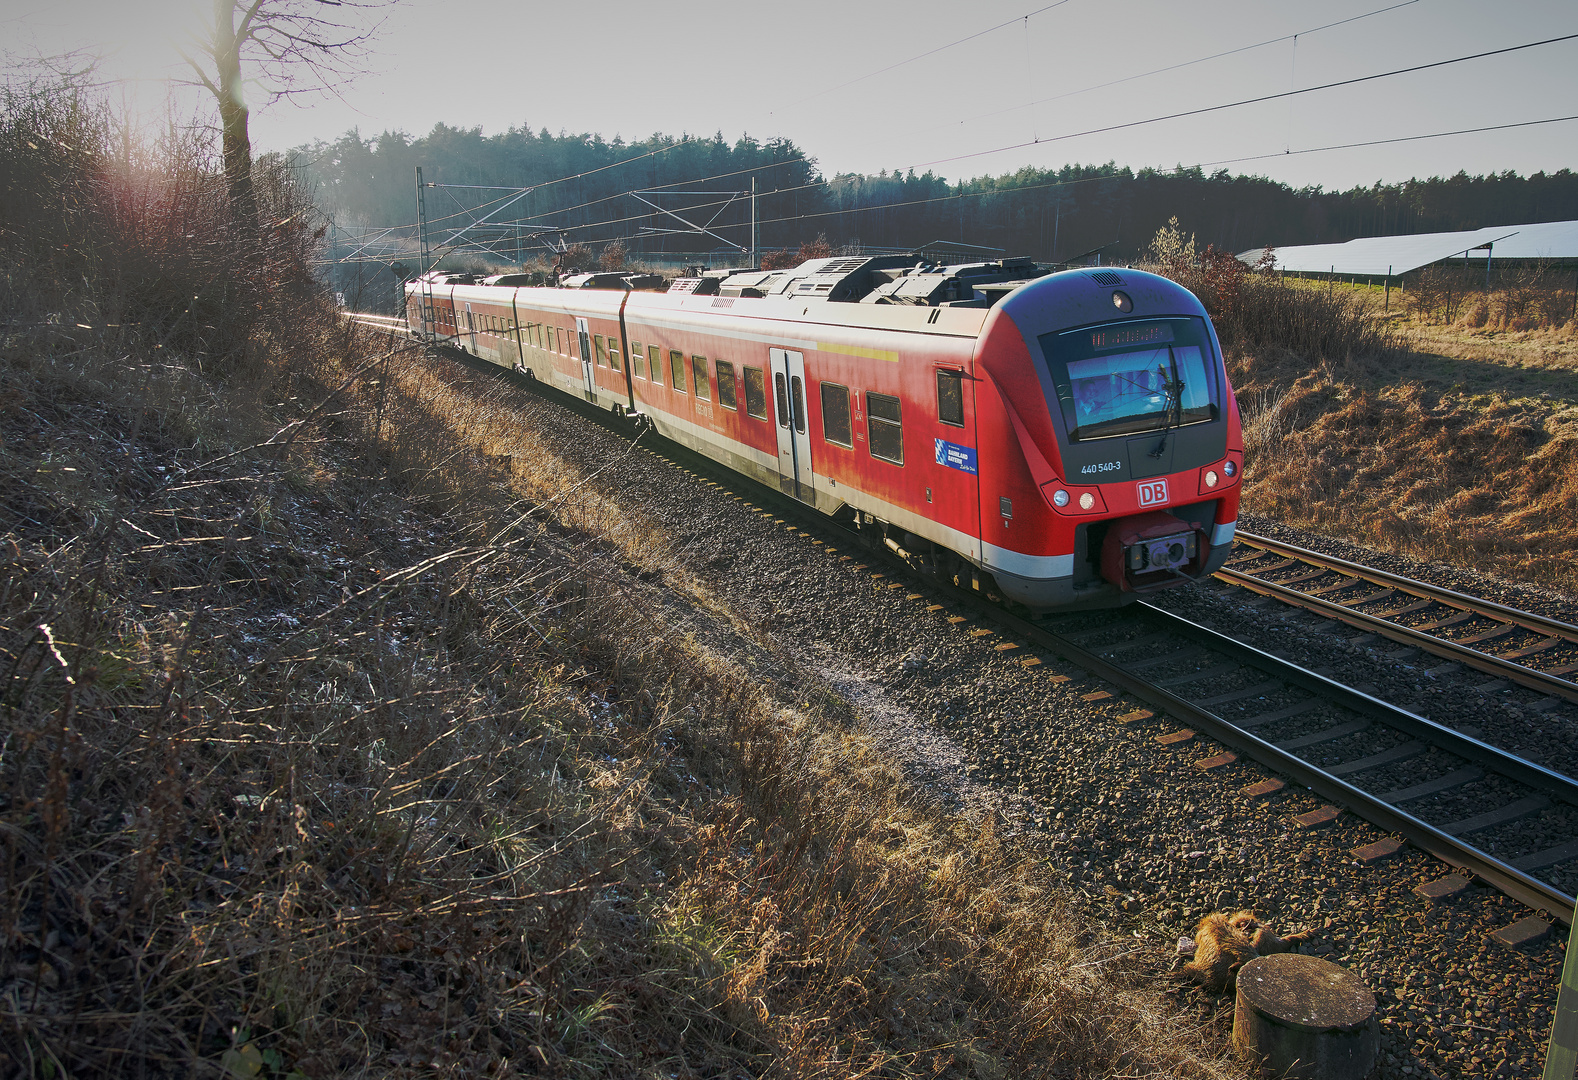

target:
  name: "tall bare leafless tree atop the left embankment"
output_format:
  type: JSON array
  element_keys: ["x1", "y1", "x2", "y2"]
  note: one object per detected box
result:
[{"x1": 181, "y1": 0, "x2": 379, "y2": 235}]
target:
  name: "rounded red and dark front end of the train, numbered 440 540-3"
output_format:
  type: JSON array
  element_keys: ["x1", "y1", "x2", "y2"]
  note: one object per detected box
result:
[{"x1": 975, "y1": 268, "x2": 1243, "y2": 611}]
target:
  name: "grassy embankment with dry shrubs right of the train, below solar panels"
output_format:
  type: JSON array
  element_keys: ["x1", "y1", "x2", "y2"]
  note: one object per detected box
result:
[{"x1": 1177, "y1": 249, "x2": 1578, "y2": 592}]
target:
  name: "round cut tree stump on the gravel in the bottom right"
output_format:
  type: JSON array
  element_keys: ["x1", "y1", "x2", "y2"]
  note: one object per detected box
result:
[{"x1": 1232, "y1": 952, "x2": 1381, "y2": 1080}]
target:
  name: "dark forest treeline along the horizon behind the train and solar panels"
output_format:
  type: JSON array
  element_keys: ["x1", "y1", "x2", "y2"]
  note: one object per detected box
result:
[{"x1": 295, "y1": 123, "x2": 1578, "y2": 262}]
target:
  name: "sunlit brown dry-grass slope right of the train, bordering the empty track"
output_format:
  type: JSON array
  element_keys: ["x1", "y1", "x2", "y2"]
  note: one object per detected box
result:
[{"x1": 1240, "y1": 350, "x2": 1578, "y2": 591}]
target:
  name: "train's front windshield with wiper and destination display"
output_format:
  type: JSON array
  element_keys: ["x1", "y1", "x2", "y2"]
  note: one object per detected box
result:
[{"x1": 1041, "y1": 317, "x2": 1221, "y2": 439}]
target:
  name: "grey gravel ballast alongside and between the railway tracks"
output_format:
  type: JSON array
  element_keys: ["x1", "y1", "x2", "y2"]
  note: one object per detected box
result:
[{"x1": 473, "y1": 363, "x2": 1559, "y2": 1078}]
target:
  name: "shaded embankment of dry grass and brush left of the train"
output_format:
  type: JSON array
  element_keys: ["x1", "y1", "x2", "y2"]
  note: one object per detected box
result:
[{"x1": 0, "y1": 73, "x2": 1234, "y2": 1077}]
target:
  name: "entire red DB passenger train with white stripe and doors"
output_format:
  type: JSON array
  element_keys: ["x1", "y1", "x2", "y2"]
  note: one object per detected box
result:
[{"x1": 406, "y1": 257, "x2": 1243, "y2": 609}]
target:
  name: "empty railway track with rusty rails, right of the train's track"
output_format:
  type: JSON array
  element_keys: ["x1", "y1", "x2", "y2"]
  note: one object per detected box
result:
[{"x1": 1217, "y1": 532, "x2": 1578, "y2": 709}]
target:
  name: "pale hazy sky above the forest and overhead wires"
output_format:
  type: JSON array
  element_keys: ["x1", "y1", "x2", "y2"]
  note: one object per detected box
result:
[{"x1": 0, "y1": 0, "x2": 1578, "y2": 189}]
